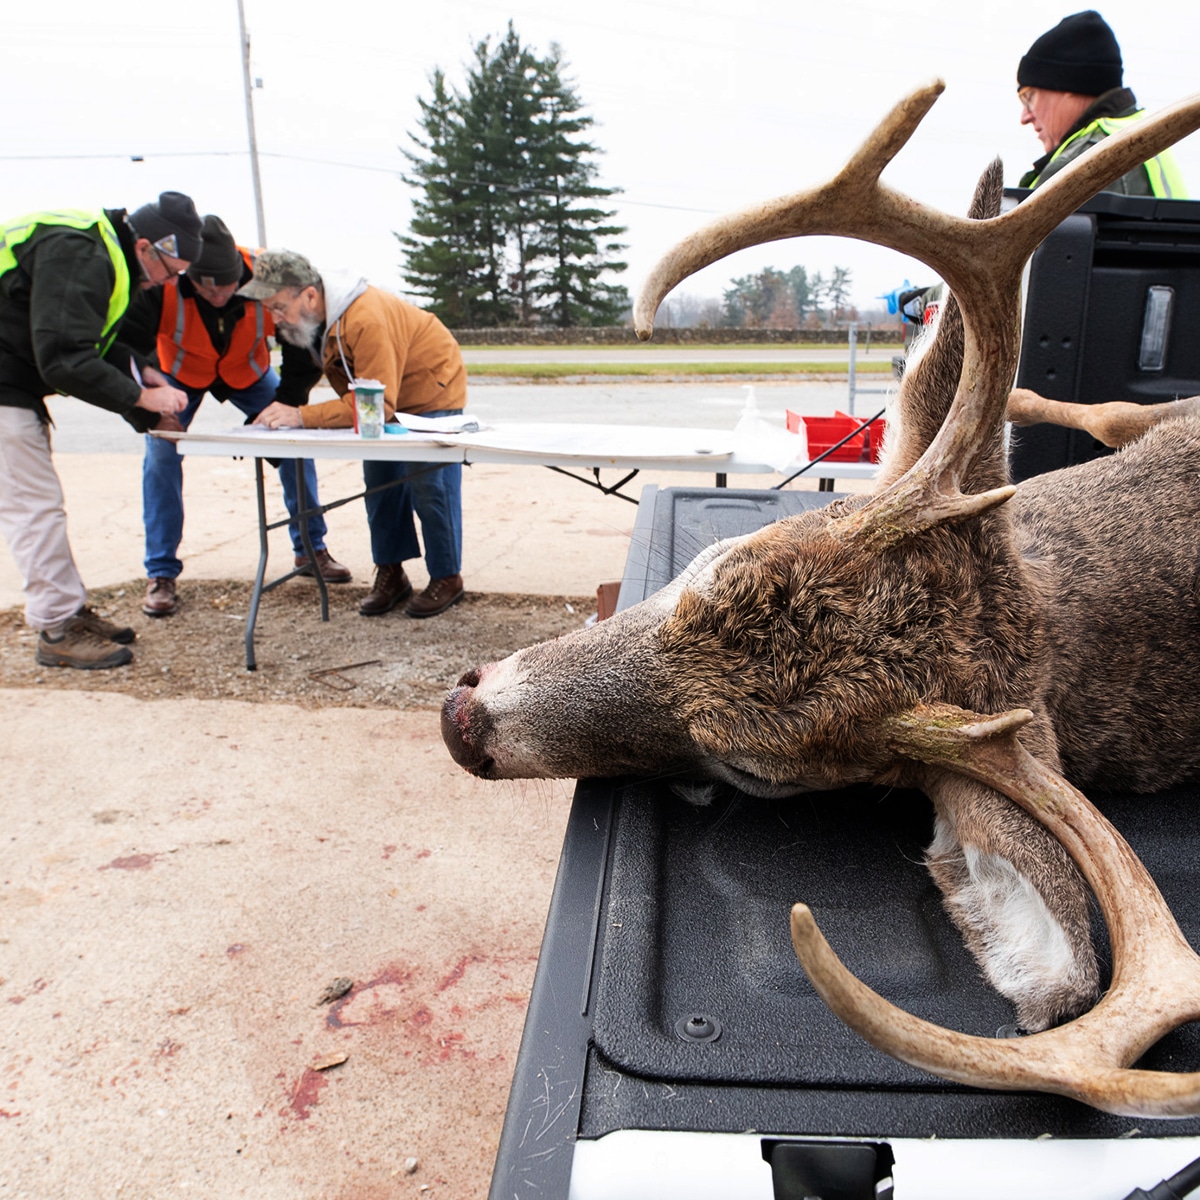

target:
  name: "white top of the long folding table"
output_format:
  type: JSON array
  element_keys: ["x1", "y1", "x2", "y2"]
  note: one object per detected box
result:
[{"x1": 154, "y1": 424, "x2": 878, "y2": 479}]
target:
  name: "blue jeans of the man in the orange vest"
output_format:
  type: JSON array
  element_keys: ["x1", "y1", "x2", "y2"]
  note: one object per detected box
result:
[{"x1": 142, "y1": 367, "x2": 325, "y2": 580}]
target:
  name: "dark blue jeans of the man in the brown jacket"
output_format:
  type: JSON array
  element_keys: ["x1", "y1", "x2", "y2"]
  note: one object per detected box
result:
[{"x1": 362, "y1": 409, "x2": 462, "y2": 580}]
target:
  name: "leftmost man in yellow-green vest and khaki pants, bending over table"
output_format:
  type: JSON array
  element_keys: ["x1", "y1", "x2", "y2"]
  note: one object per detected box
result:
[{"x1": 0, "y1": 192, "x2": 200, "y2": 671}]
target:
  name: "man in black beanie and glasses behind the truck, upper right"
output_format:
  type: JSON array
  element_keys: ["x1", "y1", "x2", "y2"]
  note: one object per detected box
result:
[{"x1": 1016, "y1": 10, "x2": 1187, "y2": 199}]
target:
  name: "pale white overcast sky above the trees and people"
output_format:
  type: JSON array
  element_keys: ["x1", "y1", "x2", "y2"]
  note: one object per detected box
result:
[{"x1": 0, "y1": 0, "x2": 1200, "y2": 316}]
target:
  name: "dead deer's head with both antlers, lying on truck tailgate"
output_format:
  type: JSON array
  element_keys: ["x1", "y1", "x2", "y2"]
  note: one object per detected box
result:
[{"x1": 443, "y1": 83, "x2": 1200, "y2": 1114}]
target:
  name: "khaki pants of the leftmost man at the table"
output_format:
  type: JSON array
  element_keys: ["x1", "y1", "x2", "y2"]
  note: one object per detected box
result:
[{"x1": 0, "y1": 404, "x2": 88, "y2": 629}]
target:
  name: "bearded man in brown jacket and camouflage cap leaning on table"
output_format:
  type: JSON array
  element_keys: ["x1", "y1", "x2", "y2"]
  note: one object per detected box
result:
[{"x1": 239, "y1": 250, "x2": 467, "y2": 617}]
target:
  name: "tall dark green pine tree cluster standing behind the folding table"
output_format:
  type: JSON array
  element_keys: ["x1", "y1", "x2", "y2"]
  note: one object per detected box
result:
[{"x1": 397, "y1": 22, "x2": 629, "y2": 328}]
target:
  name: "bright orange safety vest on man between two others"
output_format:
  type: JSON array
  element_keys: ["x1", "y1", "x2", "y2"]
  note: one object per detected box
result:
[{"x1": 158, "y1": 246, "x2": 275, "y2": 389}]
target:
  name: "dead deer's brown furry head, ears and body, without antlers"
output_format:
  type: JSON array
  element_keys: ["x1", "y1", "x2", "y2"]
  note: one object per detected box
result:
[{"x1": 443, "y1": 88, "x2": 1200, "y2": 1031}]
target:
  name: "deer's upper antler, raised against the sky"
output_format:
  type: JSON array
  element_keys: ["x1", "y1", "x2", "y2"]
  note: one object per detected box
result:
[{"x1": 635, "y1": 80, "x2": 1200, "y2": 546}]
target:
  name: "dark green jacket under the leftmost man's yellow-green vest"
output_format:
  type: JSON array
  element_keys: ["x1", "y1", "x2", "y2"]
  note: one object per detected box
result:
[{"x1": 0, "y1": 209, "x2": 156, "y2": 428}]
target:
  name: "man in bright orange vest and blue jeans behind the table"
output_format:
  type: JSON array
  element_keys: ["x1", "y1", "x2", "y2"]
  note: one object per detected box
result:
[{"x1": 122, "y1": 212, "x2": 352, "y2": 617}]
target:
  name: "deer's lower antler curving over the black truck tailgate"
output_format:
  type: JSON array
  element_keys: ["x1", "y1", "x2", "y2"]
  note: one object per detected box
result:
[{"x1": 792, "y1": 706, "x2": 1200, "y2": 1117}]
